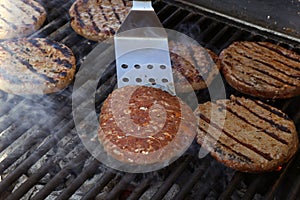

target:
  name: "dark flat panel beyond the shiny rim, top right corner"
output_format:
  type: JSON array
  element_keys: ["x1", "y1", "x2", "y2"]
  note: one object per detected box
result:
[{"x1": 183, "y1": 0, "x2": 300, "y2": 39}]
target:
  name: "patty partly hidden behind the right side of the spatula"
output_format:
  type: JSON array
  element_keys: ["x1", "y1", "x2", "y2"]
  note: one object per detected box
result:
[{"x1": 169, "y1": 41, "x2": 220, "y2": 92}]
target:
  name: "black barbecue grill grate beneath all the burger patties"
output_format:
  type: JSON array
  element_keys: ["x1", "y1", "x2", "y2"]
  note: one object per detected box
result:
[{"x1": 0, "y1": 0, "x2": 300, "y2": 200}]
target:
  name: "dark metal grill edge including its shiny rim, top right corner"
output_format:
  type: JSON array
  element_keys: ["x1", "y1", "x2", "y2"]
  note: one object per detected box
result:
[{"x1": 175, "y1": 0, "x2": 300, "y2": 43}]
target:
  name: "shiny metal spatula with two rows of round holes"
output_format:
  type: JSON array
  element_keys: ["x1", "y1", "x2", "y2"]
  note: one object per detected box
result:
[{"x1": 114, "y1": 0, "x2": 175, "y2": 95}]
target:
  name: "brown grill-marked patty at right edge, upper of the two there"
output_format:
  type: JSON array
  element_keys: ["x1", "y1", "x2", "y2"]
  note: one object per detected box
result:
[{"x1": 220, "y1": 42, "x2": 300, "y2": 98}]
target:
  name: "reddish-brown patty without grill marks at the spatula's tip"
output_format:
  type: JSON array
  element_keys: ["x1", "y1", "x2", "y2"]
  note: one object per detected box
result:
[{"x1": 98, "y1": 86, "x2": 196, "y2": 165}]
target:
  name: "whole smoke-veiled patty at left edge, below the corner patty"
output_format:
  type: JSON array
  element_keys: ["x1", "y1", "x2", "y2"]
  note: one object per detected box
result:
[{"x1": 0, "y1": 38, "x2": 76, "y2": 94}]
